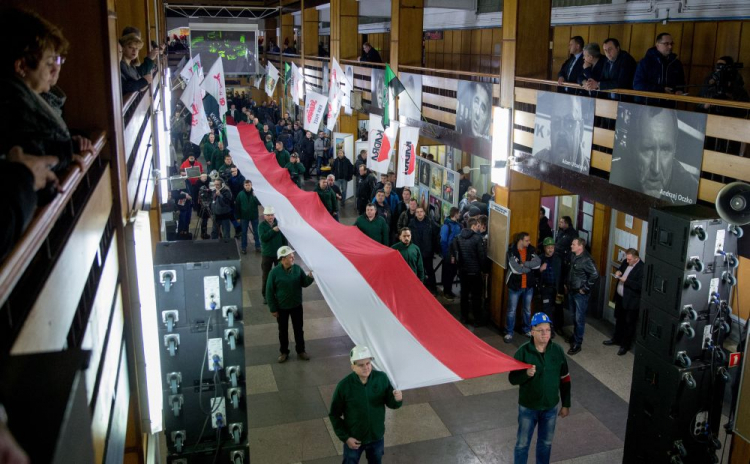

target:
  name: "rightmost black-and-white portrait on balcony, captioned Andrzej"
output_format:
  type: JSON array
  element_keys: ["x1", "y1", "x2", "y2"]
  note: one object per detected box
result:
[{"x1": 609, "y1": 103, "x2": 706, "y2": 205}]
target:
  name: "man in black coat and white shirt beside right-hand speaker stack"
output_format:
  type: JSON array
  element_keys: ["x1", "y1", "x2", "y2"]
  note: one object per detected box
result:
[{"x1": 603, "y1": 248, "x2": 644, "y2": 356}]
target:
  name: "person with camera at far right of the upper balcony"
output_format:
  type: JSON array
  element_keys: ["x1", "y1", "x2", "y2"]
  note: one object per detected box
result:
[{"x1": 698, "y1": 56, "x2": 750, "y2": 117}]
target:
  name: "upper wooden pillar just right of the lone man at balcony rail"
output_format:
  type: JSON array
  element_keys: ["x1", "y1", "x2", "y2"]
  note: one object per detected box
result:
[{"x1": 394, "y1": 0, "x2": 424, "y2": 70}]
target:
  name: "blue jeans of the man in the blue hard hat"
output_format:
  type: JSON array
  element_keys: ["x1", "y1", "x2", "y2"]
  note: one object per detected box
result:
[{"x1": 513, "y1": 404, "x2": 557, "y2": 464}]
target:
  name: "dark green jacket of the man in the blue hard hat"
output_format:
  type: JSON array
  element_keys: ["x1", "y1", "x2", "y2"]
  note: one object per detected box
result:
[{"x1": 509, "y1": 340, "x2": 570, "y2": 411}]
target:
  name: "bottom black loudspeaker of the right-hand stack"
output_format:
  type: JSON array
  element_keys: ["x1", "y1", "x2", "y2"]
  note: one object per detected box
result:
[{"x1": 623, "y1": 345, "x2": 725, "y2": 464}]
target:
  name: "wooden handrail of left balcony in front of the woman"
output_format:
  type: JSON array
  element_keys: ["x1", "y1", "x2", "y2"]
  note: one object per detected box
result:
[{"x1": 0, "y1": 132, "x2": 106, "y2": 305}]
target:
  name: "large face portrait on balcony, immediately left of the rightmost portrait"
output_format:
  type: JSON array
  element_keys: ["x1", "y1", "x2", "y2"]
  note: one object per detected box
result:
[{"x1": 532, "y1": 92, "x2": 595, "y2": 174}]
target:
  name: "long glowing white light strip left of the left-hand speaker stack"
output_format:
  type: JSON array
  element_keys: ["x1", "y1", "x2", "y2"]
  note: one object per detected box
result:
[{"x1": 133, "y1": 212, "x2": 163, "y2": 434}]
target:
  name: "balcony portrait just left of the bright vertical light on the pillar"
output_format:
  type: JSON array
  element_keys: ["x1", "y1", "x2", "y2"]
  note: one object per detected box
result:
[{"x1": 456, "y1": 81, "x2": 492, "y2": 139}]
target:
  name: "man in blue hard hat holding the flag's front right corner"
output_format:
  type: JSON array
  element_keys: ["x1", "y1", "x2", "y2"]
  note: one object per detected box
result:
[{"x1": 509, "y1": 313, "x2": 570, "y2": 464}]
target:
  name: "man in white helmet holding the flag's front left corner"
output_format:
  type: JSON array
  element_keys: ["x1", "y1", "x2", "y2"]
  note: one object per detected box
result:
[{"x1": 328, "y1": 346, "x2": 403, "y2": 464}]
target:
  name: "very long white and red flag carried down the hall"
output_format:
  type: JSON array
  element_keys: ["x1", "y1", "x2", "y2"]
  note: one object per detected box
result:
[{"x1": 227, "y1": 124, "x2": 527, "y2": 390}]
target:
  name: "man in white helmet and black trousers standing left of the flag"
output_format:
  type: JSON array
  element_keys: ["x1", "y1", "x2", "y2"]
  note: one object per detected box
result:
[{"x1": 266, "y1": 246, "x2": 313, "y2": 363}]
